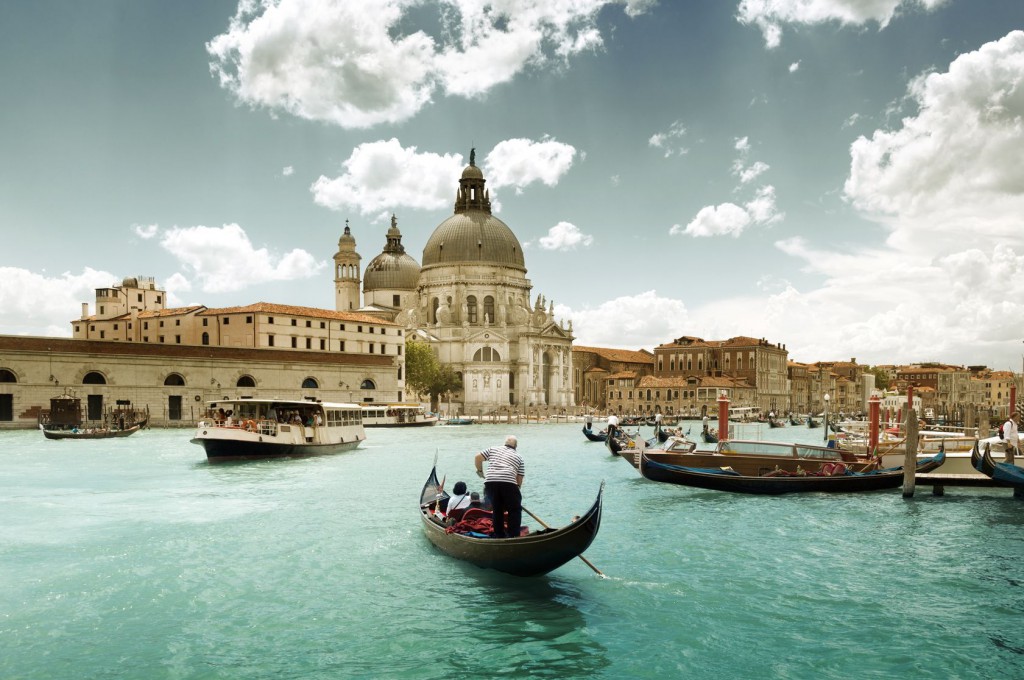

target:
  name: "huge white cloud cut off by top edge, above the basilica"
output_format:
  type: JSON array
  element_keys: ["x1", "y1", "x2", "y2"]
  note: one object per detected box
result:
[{"x1": 207, "y1": 0, "x2": 653, "y2": 128}]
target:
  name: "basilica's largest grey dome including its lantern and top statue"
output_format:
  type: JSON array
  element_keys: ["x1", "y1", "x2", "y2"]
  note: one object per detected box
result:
[{"x1": 423, "y1": 151, "x2": 526, "y2": 271}]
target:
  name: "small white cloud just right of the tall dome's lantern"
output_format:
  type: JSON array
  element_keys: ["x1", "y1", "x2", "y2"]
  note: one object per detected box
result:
[{"x1": 481, "y1": 137, "x2": 577, "y2": 194}]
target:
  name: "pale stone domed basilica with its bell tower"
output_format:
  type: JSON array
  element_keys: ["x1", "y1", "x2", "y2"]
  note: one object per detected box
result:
[{"x1": 334, "y1": 152, "x2": 572, "y2": 415}]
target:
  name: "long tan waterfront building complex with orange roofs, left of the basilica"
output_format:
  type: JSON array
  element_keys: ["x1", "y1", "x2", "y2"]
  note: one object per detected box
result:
[{"x1": 0, "y1": 277, "x2": 406, "y2": 428}]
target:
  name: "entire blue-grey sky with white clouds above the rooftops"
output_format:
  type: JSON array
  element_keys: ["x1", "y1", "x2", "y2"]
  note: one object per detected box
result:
[{"x1": 0, "y1": 0, "x2": 1024, "y2": 371}]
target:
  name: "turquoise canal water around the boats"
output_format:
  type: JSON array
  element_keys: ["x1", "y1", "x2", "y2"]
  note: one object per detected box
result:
[{"x1": 0, "y1": 424, "x2": 1024, "y2": 679}]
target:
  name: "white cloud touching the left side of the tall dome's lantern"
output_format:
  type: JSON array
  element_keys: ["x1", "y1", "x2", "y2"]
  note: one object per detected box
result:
[{"x1": 310, "y1": 138, "x2": 466, "y2": 215}]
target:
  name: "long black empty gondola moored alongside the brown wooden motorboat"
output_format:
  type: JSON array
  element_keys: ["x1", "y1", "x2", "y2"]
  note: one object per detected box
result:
[{"x1": 640, "y1": 451, "x2": 945, "y2": 495}]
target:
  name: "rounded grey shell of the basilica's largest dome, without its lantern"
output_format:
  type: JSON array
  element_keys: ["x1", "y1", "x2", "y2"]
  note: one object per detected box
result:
[{"x1": 423, "y1": 210, "x2": 526, "y2": 270}]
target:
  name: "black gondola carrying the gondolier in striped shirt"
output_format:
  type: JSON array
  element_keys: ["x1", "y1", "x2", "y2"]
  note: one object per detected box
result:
[{"x1": 420, "y1": 467, "x2": 604, "y2": 577}]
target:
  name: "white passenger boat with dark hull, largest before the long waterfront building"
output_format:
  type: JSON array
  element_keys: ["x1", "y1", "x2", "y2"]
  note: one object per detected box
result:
[{"x1": 191, "y1": 398, "x2": 367, "y2": 463}]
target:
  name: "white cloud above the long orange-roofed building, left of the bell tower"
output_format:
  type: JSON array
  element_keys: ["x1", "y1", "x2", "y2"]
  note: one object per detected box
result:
[{"x1": 160, "y1": 224, "x2": 327, "y2": 293}]
